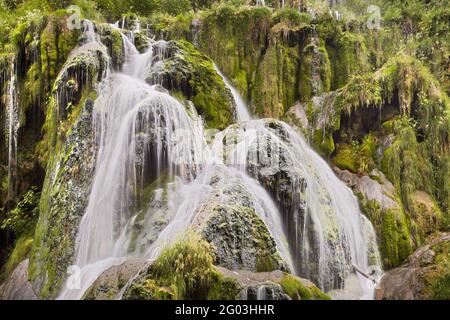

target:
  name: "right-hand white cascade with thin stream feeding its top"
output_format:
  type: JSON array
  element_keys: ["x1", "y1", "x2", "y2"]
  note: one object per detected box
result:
[{"x1": 209, "y1": 71, "x2": 381, "y2": 298}]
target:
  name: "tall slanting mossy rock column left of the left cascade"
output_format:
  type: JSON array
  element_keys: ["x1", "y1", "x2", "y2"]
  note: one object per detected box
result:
[{"x1": 30, "y1": 99, "x2": 96, "y2": 297}]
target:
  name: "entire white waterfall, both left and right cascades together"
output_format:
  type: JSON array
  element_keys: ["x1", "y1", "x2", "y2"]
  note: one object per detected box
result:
[{"x1": 59, "y1": 22, "x2": 380, "y2": 299}]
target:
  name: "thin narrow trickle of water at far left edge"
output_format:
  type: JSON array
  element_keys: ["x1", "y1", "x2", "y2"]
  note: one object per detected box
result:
[{"x1": 6, "y1": 61, "x2": 20, "y2": 199}]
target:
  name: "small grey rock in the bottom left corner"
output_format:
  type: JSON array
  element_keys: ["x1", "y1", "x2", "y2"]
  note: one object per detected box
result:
[{"x1": 0, "y1": 259, "x2": 37, "y2": 300}]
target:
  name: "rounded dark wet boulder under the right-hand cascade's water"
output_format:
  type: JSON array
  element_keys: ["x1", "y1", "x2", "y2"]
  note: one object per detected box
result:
[{"x1": 218, "y1": 119, "x2": 351, "y2": 290}]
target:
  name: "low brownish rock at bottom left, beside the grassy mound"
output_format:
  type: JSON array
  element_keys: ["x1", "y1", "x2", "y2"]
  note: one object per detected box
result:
[{"x1": 83, "y1": 259, "x2": 147, "y2": 300}]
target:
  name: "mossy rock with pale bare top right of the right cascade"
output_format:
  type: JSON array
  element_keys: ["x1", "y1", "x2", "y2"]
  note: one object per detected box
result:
[{"x1": 334, "y1": 167, "x2": 443, "y2": 268}]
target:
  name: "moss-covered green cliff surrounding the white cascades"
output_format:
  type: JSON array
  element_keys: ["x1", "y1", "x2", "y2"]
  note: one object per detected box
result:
[{"x1": 0, "y1": 0, "x2": 450, "y2": 299}]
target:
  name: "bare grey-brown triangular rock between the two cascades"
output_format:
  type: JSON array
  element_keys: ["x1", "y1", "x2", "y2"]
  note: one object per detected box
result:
[{"x1": 194, "y1": 171, "x2": 288, "y2": 272}]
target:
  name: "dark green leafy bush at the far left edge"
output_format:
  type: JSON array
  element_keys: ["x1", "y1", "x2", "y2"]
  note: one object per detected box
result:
[{"x1": 1, "y1": 187, "x2": 40, "y2": 235}]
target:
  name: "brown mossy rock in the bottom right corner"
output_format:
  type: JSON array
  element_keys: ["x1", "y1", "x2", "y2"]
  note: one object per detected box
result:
[{"x1": 376, "y1": 233, "x2": 450, "y2": 300}]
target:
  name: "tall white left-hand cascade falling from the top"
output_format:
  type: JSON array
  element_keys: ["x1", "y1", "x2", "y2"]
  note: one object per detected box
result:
[{"x1": 57, "y1": 35, "x2": 208, "y2": 298}]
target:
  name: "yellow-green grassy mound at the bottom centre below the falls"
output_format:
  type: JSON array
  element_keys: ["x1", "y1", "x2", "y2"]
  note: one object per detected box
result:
[{"x1": 125, "y1": 233, "x2": 243, "y2": 300}]
